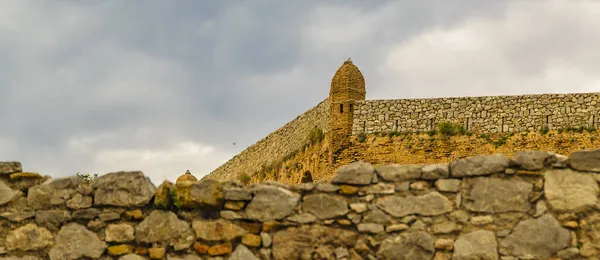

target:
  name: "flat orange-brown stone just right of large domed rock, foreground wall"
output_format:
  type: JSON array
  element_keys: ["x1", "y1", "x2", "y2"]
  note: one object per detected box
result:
[{"x1": 192, "y1": 219, "x2": 248, "y2": 241}]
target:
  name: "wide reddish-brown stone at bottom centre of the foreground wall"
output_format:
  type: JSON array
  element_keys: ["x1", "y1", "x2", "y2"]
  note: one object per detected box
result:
[{"x1": 273, "y1": 225, "x2": 358, "y2": 260}]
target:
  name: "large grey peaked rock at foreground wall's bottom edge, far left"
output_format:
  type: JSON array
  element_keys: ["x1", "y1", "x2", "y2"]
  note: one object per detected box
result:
[{"x1": 48, "y1": 222, "x2": 107, "y2": 260}]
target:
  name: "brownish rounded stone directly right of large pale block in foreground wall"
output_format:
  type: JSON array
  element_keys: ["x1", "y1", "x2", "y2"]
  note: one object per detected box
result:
[{"x1": 302, "y1": 193, "x2": 348, "y2": 219}]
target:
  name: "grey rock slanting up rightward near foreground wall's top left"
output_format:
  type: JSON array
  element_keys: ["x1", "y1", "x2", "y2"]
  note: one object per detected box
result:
[{"x1": 27, "y1": 176, "x2": 81, "y2": 209}]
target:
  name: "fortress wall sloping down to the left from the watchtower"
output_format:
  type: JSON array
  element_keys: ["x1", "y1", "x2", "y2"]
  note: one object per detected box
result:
[{"x1": 207, "y1": 99, "x2": 329, "y2": 180}]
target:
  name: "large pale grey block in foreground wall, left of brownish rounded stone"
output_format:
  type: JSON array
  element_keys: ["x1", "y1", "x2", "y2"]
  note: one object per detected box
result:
[{"x1": 246, "y1": 185, "x2": 300, "y2": 222}]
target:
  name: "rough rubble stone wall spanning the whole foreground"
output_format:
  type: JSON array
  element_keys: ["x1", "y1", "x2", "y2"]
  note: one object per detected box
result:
[{"x1": 0, "y1": 150, "x2": 600, "y2": 260}]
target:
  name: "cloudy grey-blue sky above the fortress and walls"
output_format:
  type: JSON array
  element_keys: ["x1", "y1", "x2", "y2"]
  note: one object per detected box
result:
[{"x1": 0, "y1": 0, "x2": 600, "y2": 185}]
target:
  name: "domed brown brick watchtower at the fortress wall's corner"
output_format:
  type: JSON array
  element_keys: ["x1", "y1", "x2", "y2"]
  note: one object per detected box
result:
[{"x1": 327, "y1": 58, "x2": 366, "y2": 163}]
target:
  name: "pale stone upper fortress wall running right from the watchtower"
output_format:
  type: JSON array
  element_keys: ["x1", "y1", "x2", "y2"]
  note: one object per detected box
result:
[{"x1": 352, "y1": 93, "x2": 600, "y2": 135}]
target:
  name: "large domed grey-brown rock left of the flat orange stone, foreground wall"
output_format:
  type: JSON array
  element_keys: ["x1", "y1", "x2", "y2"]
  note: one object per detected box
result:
[{"x1": 135, "y1": 210, "x2": 195, "y2": 251}]
